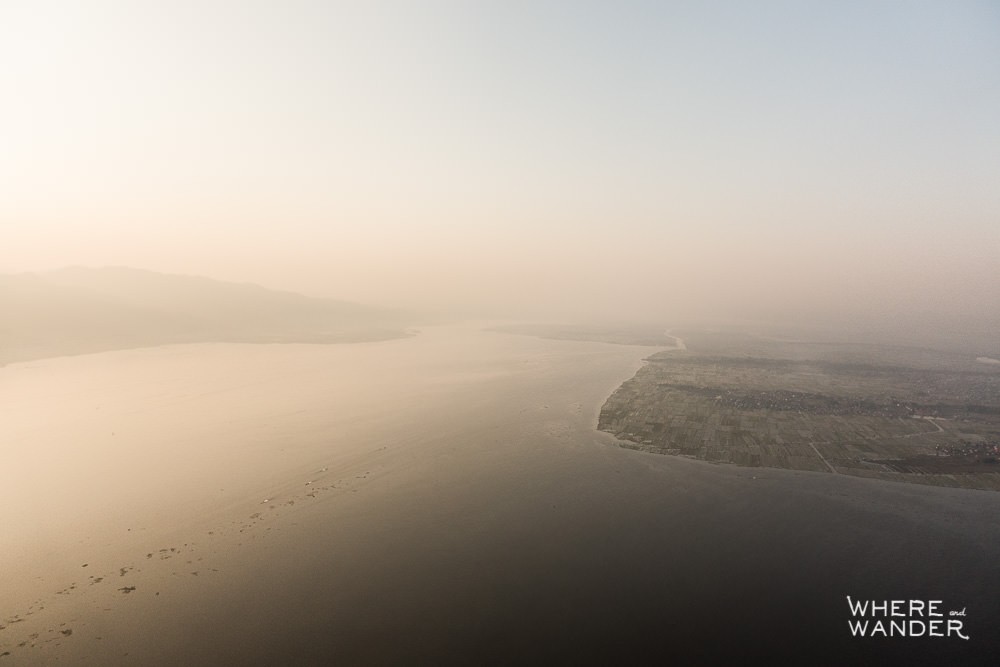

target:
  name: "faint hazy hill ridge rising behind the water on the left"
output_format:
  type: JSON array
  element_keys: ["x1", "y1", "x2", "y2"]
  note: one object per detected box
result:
[{"x1": 0, "y1": 267, "x2": 405, "y2": 363}]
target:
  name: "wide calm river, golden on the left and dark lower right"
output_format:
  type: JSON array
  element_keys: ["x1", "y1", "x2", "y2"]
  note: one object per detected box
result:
[{"x1": 0, "y1": 326, "x2": 1000, "y2": 667}]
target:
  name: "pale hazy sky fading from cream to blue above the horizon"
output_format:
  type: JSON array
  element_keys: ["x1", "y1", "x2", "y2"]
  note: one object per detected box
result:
[{"x1": 0, "y1": 0, "x2": 1000, "y2": 326}]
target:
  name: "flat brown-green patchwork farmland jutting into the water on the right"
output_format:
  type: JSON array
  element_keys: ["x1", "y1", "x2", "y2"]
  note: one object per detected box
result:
[{"x1": 599, "y1": 334, "x2": 1000, "y2": 490}]
